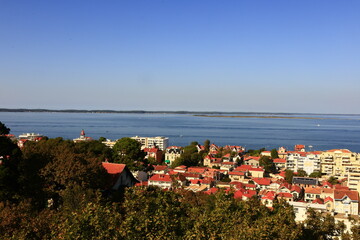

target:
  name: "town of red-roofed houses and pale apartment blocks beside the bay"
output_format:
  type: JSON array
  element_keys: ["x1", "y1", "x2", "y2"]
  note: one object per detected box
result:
[{"x1": 3, "y1": 130, "x2": 360, "y2": 228}]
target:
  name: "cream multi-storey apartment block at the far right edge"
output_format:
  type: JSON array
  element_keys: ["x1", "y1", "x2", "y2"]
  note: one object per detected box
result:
[{"x1": 320, "y1": 149, "x2": 360, "y2": 177}]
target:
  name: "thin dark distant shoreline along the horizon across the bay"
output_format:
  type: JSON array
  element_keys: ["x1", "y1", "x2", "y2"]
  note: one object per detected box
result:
[{"x1": 0, "y1": 108, "x2": 360, "y2": 116}]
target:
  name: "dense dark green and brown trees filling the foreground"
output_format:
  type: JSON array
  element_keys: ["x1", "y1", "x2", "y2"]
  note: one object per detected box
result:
[{"x1": 0, "y1": 128, "x2": 360, "y2": 239}]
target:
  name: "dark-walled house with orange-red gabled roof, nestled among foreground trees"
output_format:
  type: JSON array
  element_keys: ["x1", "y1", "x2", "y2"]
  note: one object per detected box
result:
[{"x1": 102, "y1": 162, "x2": 139, "y2": 190}]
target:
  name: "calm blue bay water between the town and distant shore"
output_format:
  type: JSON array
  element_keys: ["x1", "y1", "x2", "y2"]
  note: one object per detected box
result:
[{"x1": 0, "y1": 112, "x2": 360, "y2": 152}]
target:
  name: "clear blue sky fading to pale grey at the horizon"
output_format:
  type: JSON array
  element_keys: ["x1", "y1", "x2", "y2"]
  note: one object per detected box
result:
[{"x1": 0, "y1": 0, "x2": 360, "y2": 113}]
